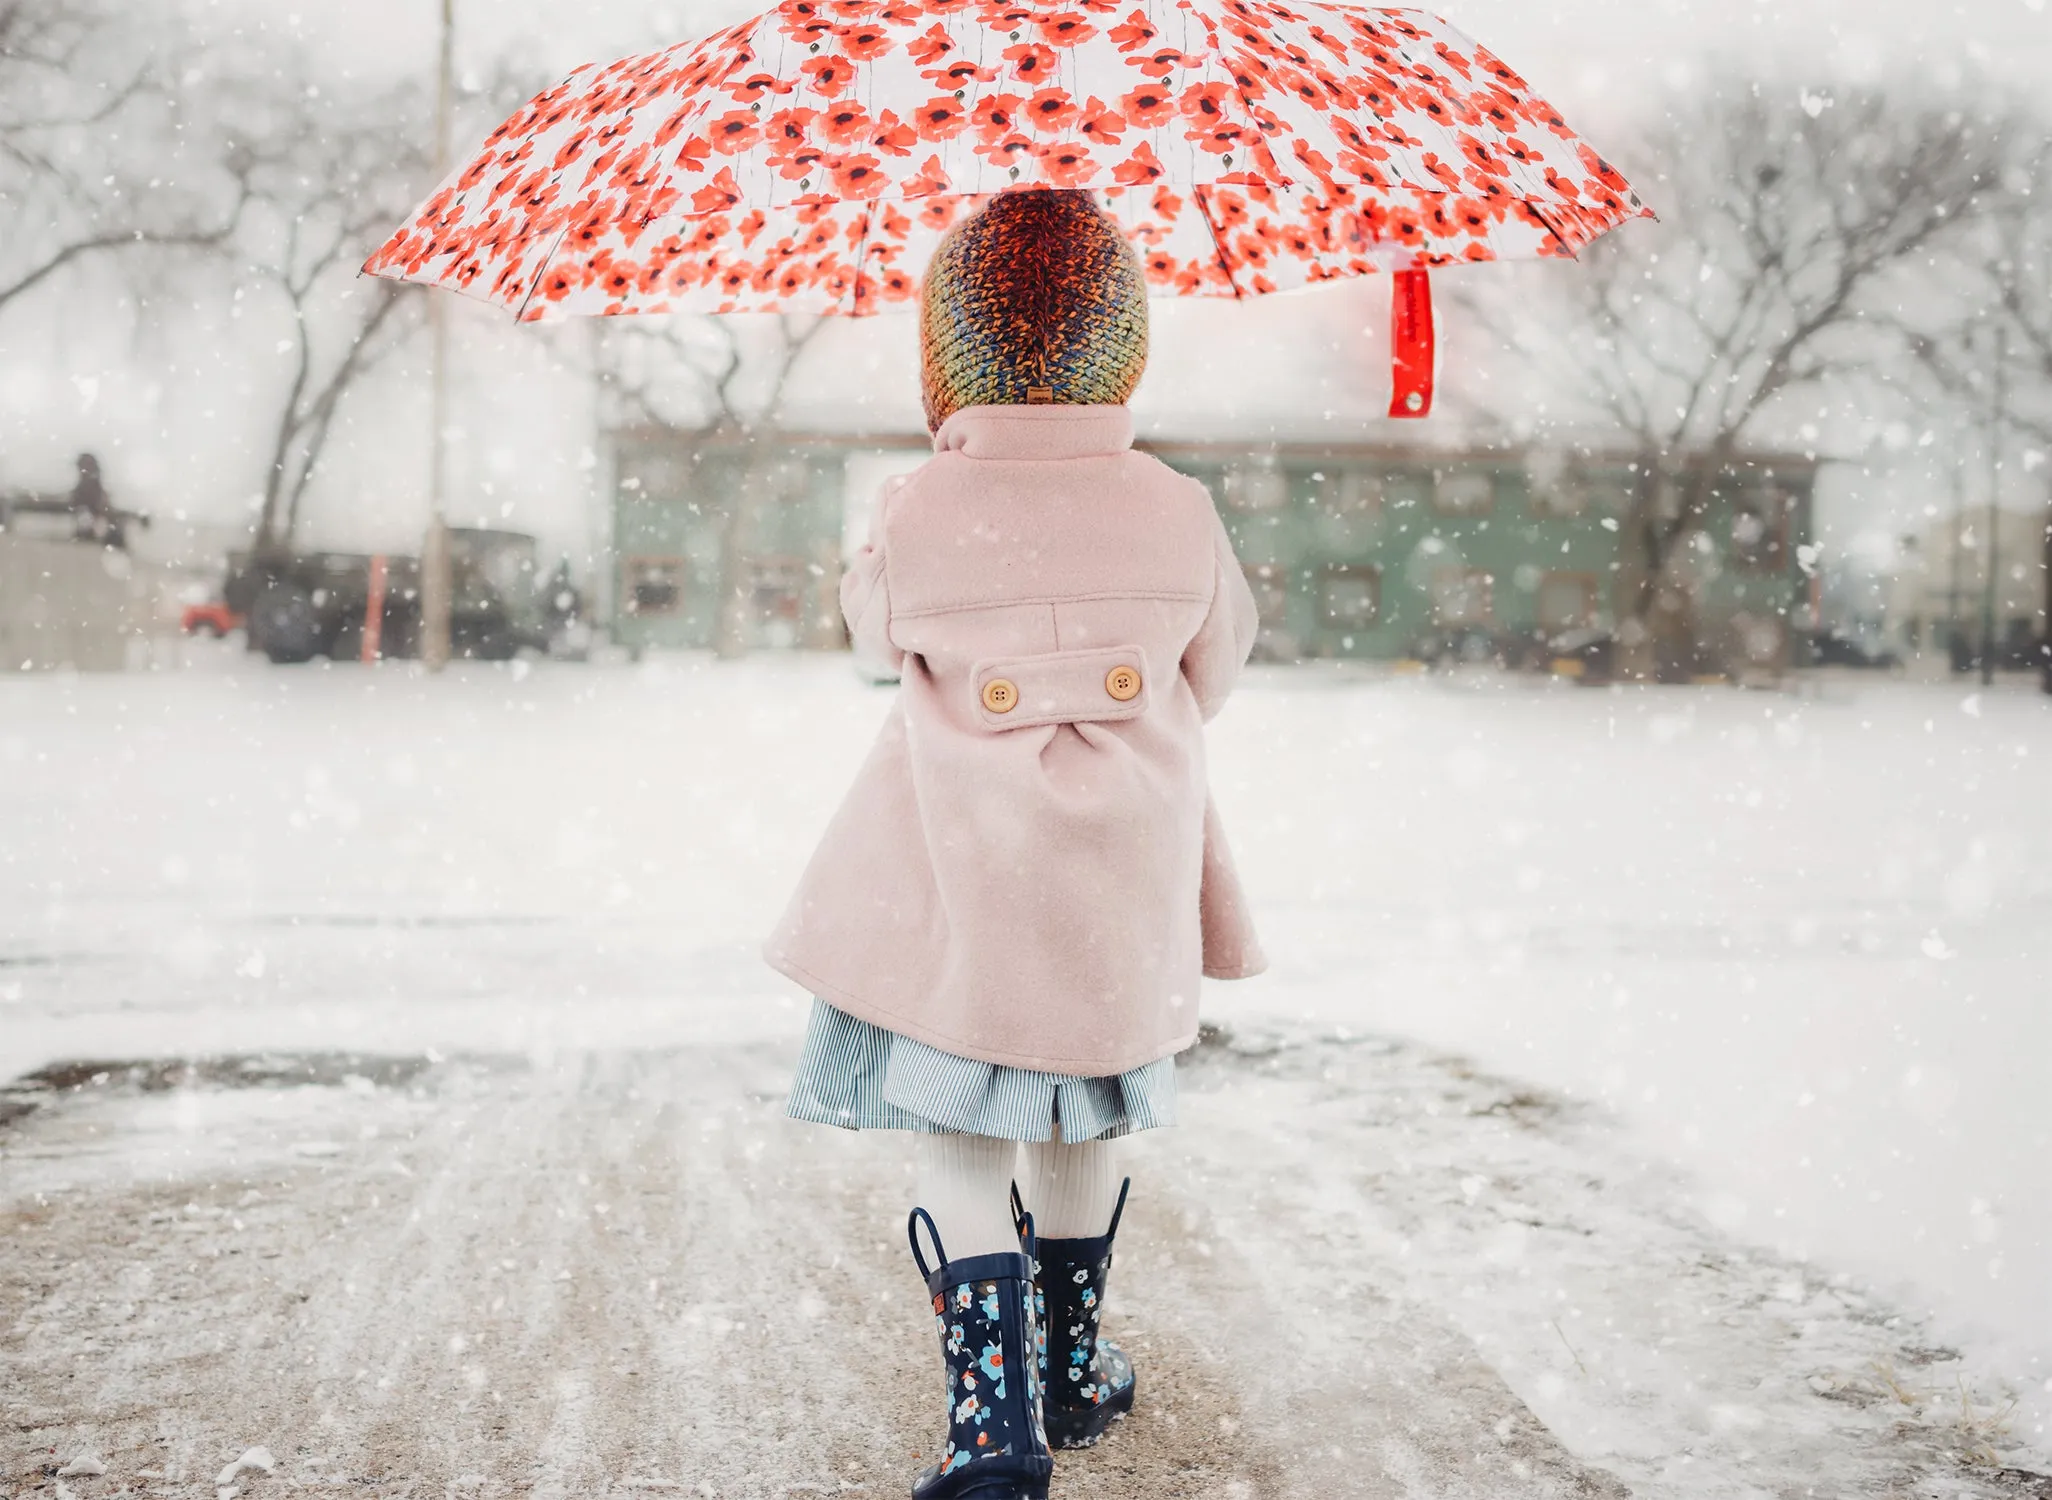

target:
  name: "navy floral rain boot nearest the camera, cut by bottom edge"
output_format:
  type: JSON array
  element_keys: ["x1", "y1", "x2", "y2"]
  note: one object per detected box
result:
[{"x1": 905, "y1": 1209, "x2": 1055, "y2": 1500}]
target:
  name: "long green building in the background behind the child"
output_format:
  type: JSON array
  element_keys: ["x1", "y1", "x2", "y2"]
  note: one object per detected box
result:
[{"x1": 611, "y1": 429, "x2": 1816, "y2": 675}]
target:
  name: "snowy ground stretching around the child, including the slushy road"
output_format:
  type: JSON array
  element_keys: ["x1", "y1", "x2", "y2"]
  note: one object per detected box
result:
[{"x1": 0, "y1": 657, "x2": 2052, "y2": 1500}]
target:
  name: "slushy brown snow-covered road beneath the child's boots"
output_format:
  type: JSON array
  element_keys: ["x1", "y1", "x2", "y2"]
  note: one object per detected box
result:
[{"x1": 0, "y1": 1036, "x2": 2046, "y2": 1500}]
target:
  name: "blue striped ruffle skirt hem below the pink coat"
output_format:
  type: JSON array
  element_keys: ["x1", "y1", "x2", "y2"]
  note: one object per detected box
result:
[{"x1": 786, "y1": 999, "x2": 1176, "y2": 1141}]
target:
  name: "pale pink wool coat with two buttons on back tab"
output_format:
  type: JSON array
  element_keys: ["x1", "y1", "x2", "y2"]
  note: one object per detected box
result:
[{"x1": 767, "y1": 406, "x2": 1264, "y2": 1077}]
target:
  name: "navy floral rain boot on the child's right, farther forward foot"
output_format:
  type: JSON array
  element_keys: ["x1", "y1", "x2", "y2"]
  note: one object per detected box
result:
[{"x1": 1012, "y1": 1178, "x2": 1133, "y2": 1449}]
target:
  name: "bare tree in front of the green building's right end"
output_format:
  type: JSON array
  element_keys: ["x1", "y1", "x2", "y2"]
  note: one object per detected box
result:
[{"x1": 1482, "y1": 84, "x2": 1995, "y2": 675}]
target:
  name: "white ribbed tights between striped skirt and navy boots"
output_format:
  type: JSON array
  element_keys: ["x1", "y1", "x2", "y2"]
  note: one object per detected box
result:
[{"x1": 917, "y1": 1135, "x2": 1120, "y2": 1260}]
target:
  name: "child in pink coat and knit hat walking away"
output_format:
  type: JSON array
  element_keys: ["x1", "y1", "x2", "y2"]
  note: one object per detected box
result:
[{"x1": 767, "y1": 189, "x2": 1262, "y2": 1500}]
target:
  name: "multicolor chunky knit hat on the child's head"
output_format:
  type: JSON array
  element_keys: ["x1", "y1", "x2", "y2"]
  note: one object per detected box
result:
[{"x1": 919, "y1": 189, "x2": 1147, "y2": 431}]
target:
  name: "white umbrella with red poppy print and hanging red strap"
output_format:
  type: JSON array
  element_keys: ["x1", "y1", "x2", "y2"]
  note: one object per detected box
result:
[{"x1": 365, "y1": 0, "x2": 1648, "y2": 415}]
